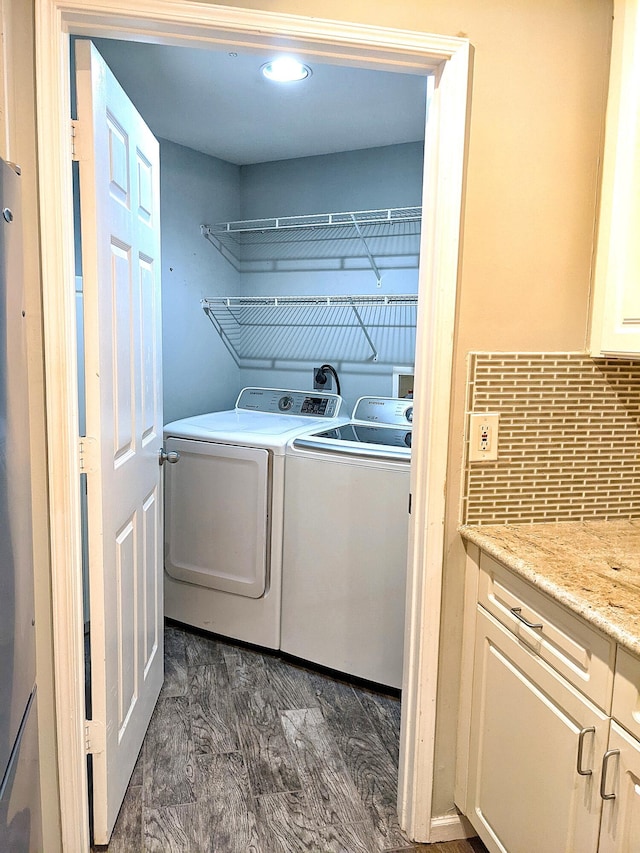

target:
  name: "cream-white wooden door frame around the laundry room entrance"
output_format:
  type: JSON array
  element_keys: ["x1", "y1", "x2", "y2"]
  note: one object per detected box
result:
[{"x1": 35, "y1": 0, "x2": 470, "y2": 851}]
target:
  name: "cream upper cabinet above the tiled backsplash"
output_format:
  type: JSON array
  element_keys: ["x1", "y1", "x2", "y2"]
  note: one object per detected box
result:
[{"x1": 590, "y1": 0, "x2": 640, "y2": 358}]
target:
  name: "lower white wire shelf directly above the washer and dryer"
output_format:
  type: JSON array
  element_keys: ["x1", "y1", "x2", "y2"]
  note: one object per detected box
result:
[{"x1": 201, "y1": 294, "x2": 418, "y2": 367}]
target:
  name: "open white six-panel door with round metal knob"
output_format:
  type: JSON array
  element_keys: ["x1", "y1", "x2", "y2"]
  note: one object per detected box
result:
[{"x1": 75, "y1": 41, "x2": 163, "y2": 844}]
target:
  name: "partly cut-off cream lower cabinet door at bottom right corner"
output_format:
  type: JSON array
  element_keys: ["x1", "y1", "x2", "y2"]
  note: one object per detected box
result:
[{"x1": 599, "y1": 722, "x2": 640, "y2": 853}]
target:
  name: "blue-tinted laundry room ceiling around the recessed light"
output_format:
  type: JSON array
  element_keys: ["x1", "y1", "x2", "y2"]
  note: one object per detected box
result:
[{"x1": 94, "y1": 39, "x2": 427, "y2": 165}]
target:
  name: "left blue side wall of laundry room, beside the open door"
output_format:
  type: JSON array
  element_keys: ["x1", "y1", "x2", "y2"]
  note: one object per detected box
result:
[{"x1": 160, "y1": 140, "x2": 241, "y2": 423}]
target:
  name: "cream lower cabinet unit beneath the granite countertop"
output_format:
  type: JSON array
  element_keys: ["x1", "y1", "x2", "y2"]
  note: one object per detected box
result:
[{"x1": 456, "y1": 554, "x2": 640, "y2": 853}]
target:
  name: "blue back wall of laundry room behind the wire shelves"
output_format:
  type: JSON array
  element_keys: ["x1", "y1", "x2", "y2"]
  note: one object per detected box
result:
[{"x1": 232, "y1": 143, "x2": 424, "y2": 411}]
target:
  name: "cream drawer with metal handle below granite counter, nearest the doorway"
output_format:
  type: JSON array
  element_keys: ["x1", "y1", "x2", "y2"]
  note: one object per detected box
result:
[{"x1": 478, "y1": 552, "x2": 615, "y2": 712}]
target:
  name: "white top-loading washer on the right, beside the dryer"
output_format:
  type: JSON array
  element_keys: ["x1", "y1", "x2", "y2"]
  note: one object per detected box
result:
[{"x1": 281, "y1": 397, "x2": 413, "y2": 688}]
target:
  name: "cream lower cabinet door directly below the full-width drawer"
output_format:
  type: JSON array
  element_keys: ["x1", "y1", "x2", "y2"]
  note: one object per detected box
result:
[{"x1": 467, "y1": 607, "x2": 608, "y2": 853}]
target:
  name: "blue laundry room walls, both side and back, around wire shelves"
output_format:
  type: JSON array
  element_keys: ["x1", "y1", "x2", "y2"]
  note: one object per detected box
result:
[{"x1": 160, "y1": 141, "x2": 423, "y2": 422}]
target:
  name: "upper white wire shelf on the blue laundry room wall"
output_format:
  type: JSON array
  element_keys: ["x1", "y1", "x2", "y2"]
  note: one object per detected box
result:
[{"x1": 200, "y1": 207, "x2": 422, "y2": 284}]
